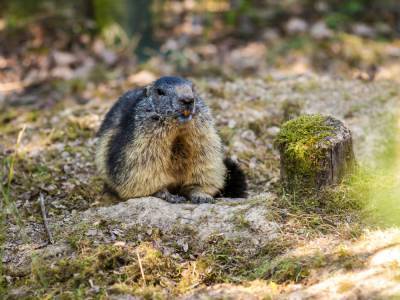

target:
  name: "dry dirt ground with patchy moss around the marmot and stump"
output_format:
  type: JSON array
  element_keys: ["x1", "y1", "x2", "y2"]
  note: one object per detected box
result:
[{"x1": 0, "y1": 75, "x2": 400, "y2": 299}]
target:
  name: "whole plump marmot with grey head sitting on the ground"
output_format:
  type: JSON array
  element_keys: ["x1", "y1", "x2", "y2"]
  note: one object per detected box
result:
[{"x1": 96, "y1": 76, "x2": 247, "y2": 203}]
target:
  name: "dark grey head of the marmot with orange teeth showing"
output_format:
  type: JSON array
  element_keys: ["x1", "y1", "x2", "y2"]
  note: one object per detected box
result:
[{"x1": 138, "y1": 76, "x2": 207, "y2": 123}]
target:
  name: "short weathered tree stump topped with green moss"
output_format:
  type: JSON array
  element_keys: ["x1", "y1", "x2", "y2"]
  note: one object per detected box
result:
[{"x1": 276, "y1": 115, "x2": 355, "y2": 192}]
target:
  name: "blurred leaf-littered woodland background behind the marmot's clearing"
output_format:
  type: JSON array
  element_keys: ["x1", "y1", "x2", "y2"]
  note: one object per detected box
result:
[{"x1": 0, "y1": 0, "x2": 400, "y2": 78}]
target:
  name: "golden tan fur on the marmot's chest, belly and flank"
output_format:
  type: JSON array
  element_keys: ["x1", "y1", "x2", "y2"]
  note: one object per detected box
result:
[{"x1": 96, "y1": 120, "x2": 226, "y2": 199}]
